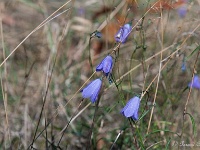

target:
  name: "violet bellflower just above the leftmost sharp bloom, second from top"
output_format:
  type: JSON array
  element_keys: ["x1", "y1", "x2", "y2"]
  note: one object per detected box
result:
[{"x1": 96, "y1": 55, "x2": 113, "y2": 76}]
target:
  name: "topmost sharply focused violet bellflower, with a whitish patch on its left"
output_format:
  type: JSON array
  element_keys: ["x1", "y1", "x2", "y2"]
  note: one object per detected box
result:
[{"x1": 115, "y1": 23, "x2": 132, "y2": 43}]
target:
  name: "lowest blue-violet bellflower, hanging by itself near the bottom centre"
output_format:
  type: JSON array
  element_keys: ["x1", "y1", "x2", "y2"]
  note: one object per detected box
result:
[{"x1": 121, "y1": 96, "x2": 140, "y2": 121}]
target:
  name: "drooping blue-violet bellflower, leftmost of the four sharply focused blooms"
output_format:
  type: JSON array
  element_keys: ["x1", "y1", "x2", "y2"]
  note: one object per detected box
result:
[{"x1": 81, "y1": 79, "x2": 102, "y2": 103}]
